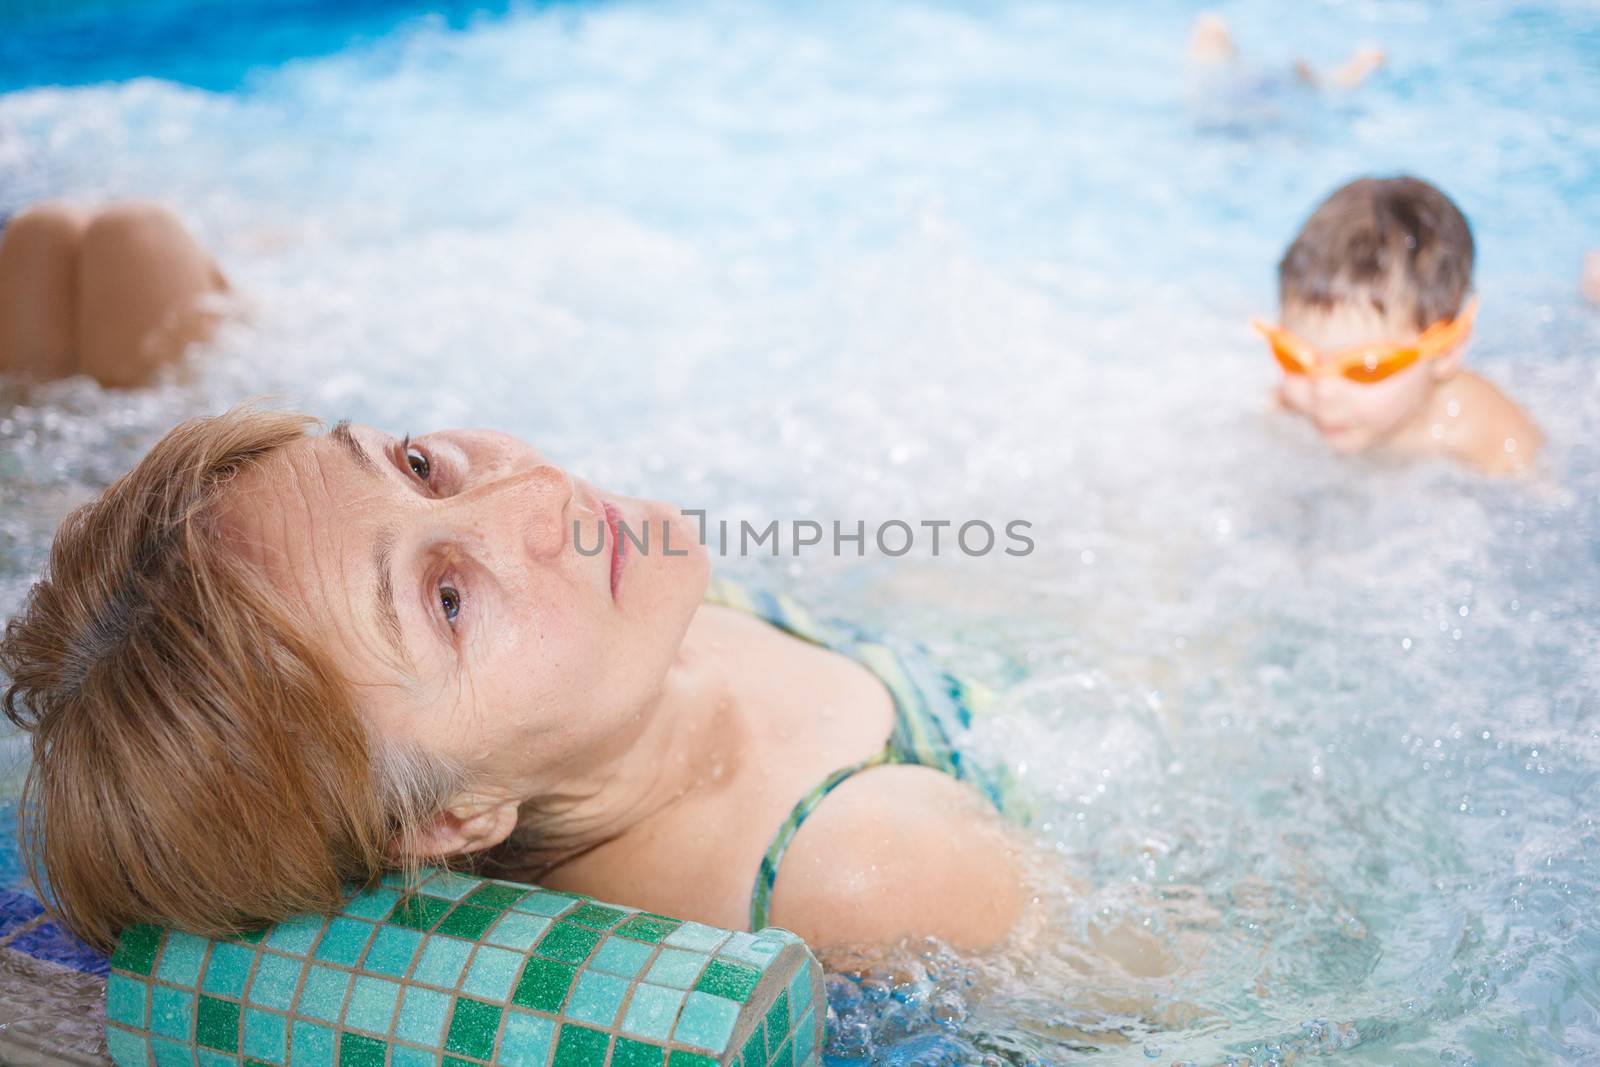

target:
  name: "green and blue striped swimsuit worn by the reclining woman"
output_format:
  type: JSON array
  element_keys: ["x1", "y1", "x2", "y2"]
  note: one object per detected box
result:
[{"x1": 706, "y1": 577, "x2": 1018, "y2": 929}]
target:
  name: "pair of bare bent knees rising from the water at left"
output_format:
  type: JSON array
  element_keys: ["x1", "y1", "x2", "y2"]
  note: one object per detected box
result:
[{"x1": 0, "y1": 200, "x2": 227, "y2": 387}]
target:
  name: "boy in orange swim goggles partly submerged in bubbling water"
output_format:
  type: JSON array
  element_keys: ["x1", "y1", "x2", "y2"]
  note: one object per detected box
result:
[{"x1": 1254, "y1": 178, "x2": 1542, "y2": 472}]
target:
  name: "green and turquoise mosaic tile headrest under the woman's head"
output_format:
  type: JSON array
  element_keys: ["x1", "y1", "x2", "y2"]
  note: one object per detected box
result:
[{"x1": 106, "y1": 872, "x2": 827, "y2": 1067}]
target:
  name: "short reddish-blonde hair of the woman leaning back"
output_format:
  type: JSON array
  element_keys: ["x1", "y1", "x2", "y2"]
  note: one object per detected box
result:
[{"x1": 0, "y1": 408, "x2": 461, "y2": 949}]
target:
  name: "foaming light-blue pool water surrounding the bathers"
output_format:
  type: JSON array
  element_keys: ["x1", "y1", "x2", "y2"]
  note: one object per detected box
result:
[{"x1": 0, "y1": 0, "x2": 1600, "y2": 1067}]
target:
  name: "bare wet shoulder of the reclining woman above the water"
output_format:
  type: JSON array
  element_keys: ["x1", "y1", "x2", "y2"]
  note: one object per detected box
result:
[{"x1": 771, "y1": 765, "x2": 1024, "y2": 949}]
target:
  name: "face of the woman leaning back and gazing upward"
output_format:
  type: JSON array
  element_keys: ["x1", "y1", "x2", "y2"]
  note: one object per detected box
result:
[{"x1": 226, "y1": 424, "x2": 707, "y2": 795}]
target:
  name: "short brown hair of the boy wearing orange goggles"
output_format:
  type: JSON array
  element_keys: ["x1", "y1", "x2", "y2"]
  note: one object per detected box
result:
[{"x1": 1278, "y1": 178, "x2": 1472, "y2": 330}]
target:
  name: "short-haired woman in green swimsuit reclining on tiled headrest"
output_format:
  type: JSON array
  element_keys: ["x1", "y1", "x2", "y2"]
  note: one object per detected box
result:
[{"x1": 0, "y1": 410, "x2": 1024, "y2": 947}]
